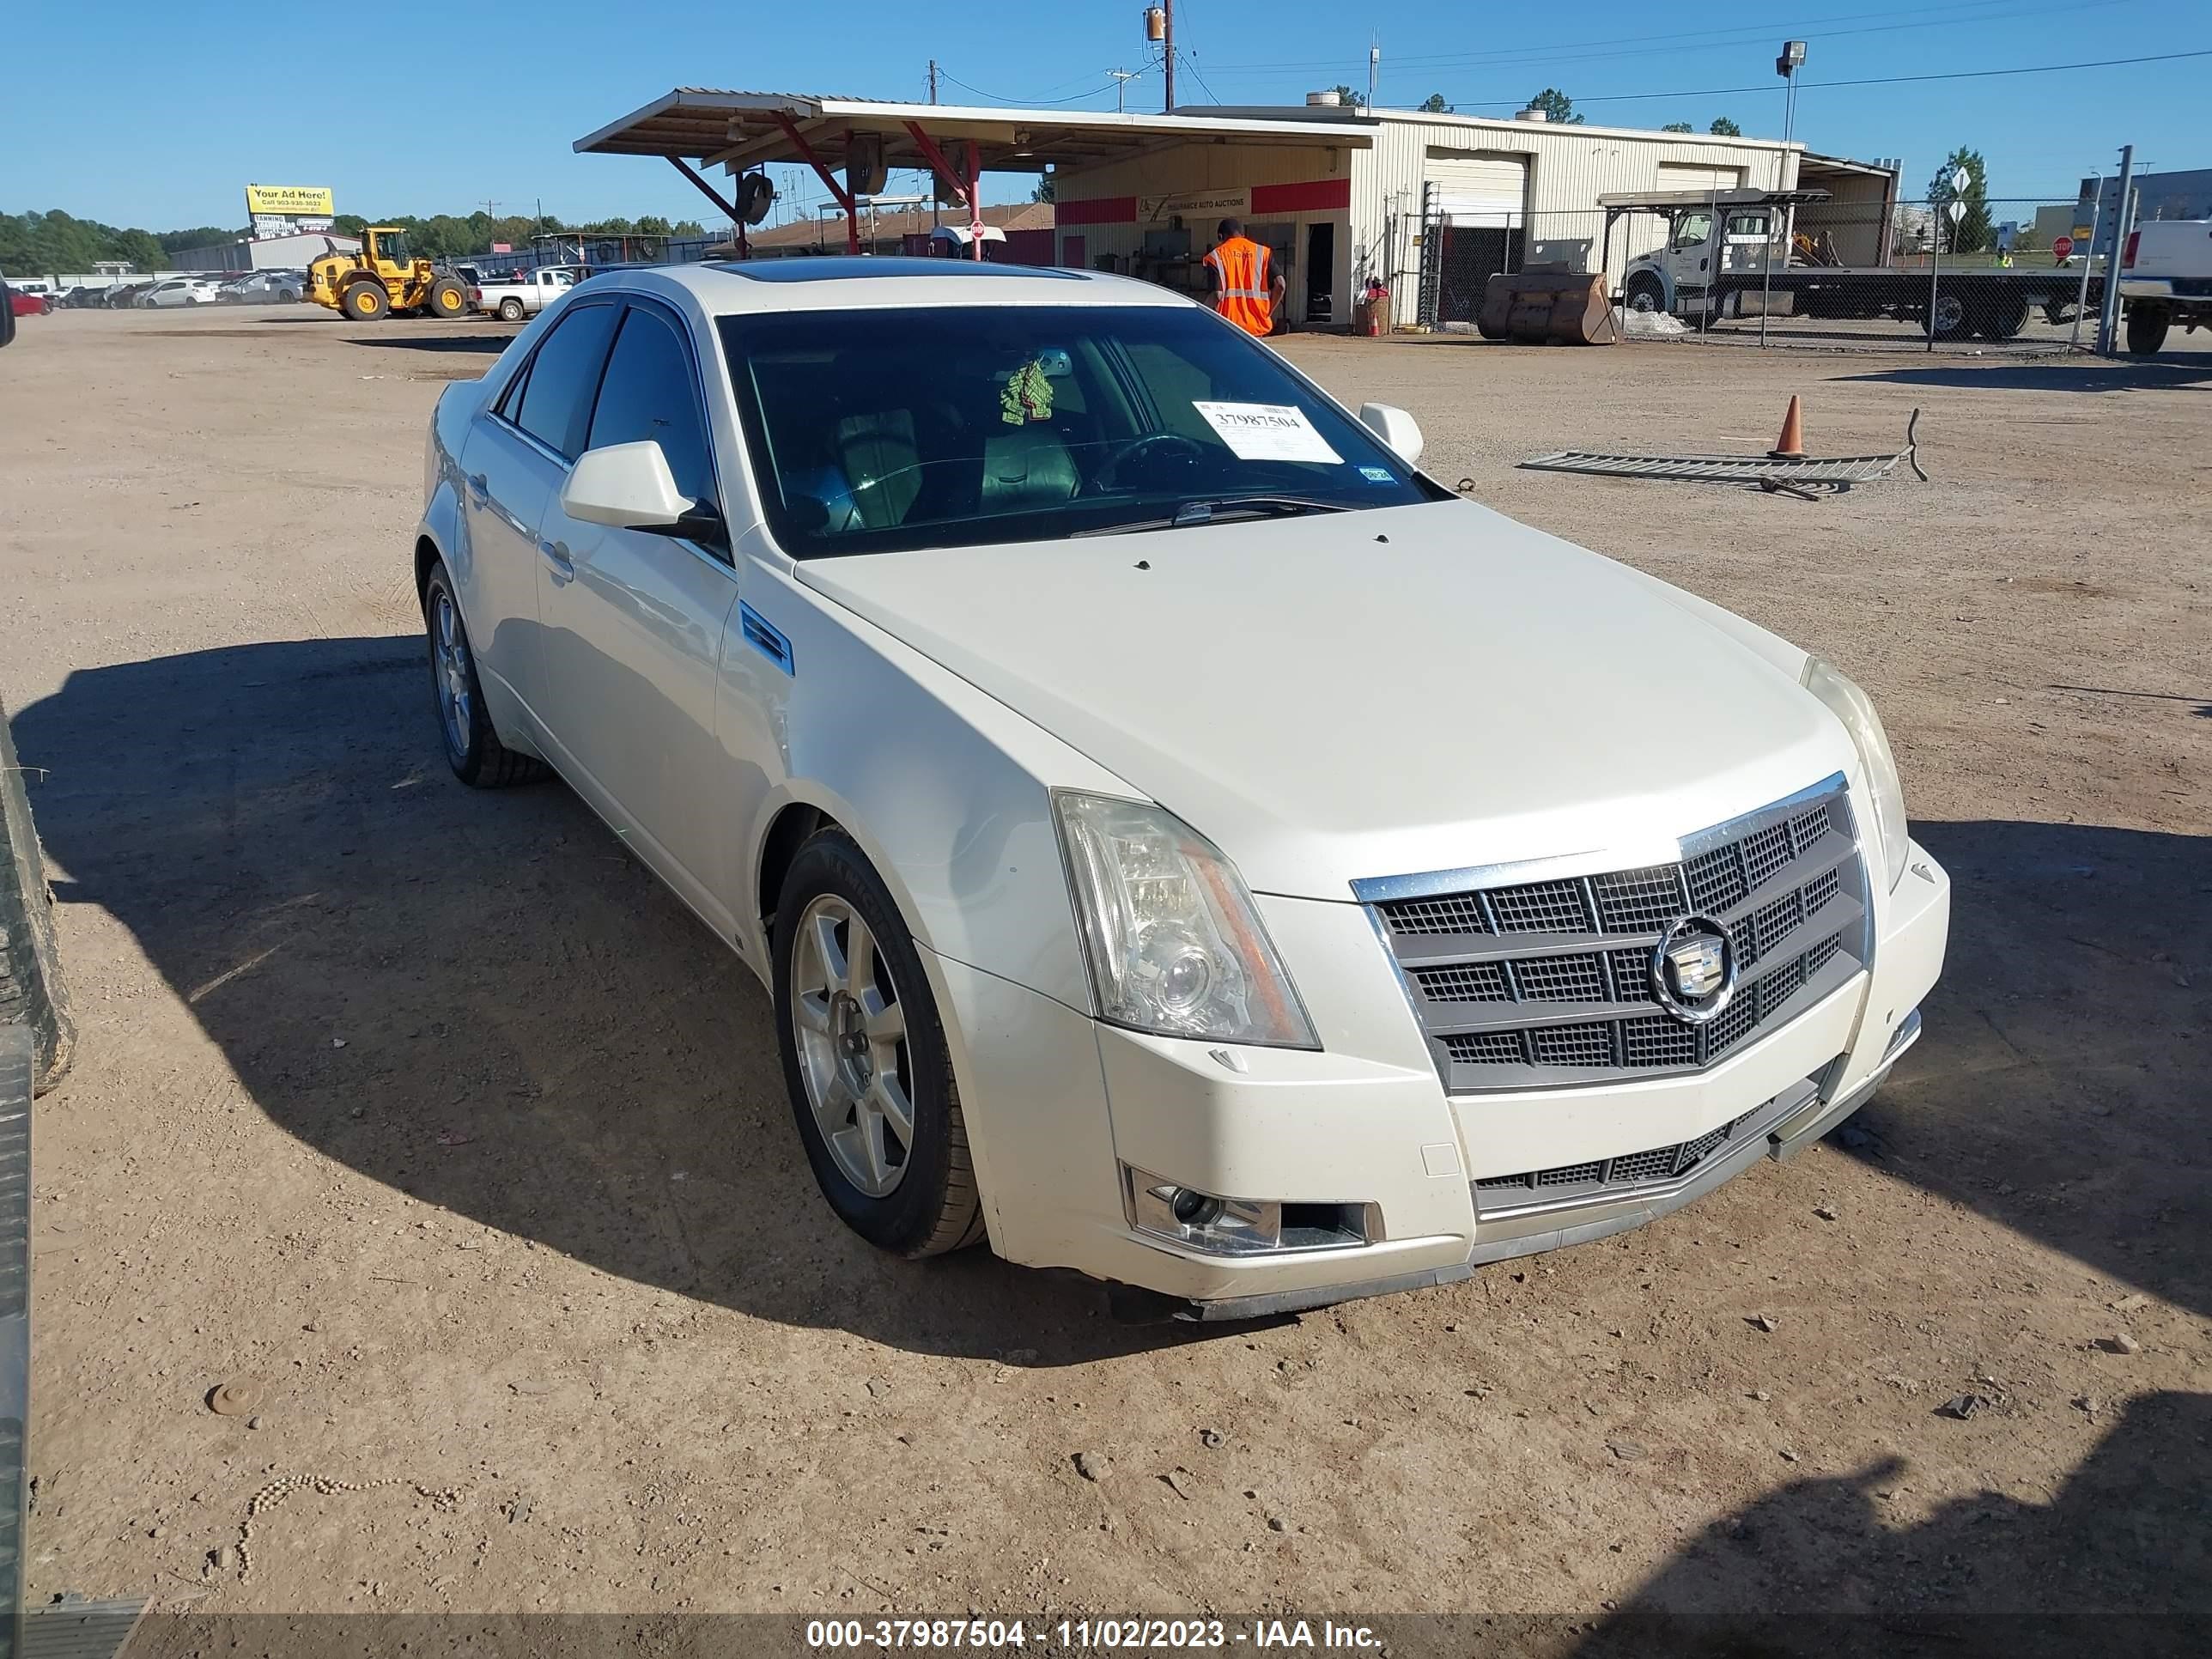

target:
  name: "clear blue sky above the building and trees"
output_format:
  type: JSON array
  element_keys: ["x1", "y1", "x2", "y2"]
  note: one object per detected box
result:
[{"x1": 0, "y1": 0, "x2": 2212, "y2": 230}]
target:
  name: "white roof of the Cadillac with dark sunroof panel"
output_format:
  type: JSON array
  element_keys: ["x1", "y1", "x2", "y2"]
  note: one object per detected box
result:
[{"x1": 591, "y1": 254, "x2": 1190, "y2": 314}]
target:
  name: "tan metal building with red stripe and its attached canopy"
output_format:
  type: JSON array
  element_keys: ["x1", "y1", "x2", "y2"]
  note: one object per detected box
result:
[{"x1": 575, "y1": 86, "x2": 1896, "y2": 327}]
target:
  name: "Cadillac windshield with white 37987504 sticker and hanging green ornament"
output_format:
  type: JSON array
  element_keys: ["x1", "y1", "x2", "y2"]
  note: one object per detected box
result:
[{"x1": 721, "y1": 305, "x2": 1443, "y2": 557}]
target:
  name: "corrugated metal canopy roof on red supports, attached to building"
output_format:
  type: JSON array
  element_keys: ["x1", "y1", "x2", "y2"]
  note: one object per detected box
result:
[{"x1": 575, "y1": 86, "x2": 1374, "y2": 173}]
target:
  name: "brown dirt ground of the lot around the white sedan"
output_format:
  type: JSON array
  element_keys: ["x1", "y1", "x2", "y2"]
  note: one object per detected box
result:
[{"x1": 0, "y1": 307, "x2": 2212, "y2": 1645}]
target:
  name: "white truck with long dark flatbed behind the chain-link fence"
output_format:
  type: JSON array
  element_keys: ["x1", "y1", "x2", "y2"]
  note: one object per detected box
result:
[{"x1": 1597, "y1": 191, "x2": 2104, "y2": 341}]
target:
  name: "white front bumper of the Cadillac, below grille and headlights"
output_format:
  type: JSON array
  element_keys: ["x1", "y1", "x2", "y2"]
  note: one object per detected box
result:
[{"x1": 925, "y1": 845, "x2": 1951, "y2": 1321}]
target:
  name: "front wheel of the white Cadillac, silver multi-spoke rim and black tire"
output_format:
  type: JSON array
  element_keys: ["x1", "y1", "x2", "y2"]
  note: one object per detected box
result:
[{"x1": 775, "y1": 830, "x2": 984, "y2": 1259}]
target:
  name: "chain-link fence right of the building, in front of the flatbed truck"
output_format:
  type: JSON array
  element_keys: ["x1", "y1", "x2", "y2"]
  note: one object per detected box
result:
[{"x1": 1418, "y1": 192, "x2": 2106, "y2": 354}]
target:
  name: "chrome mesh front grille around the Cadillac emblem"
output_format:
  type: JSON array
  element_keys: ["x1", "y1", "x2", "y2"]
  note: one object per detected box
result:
[{"x1": 1356, "y1": 775, "x2": 1869, "y2": 1093}]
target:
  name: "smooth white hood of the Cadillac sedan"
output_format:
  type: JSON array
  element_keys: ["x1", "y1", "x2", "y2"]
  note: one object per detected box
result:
[{"x1": 801, "y1": 502, "x2": 1851, "y2": 900}]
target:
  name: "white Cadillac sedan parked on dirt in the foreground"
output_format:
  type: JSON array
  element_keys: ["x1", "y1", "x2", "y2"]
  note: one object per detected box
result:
[{"x1": 416, "y1": 258, "x2": 1948, "y2": 1318}]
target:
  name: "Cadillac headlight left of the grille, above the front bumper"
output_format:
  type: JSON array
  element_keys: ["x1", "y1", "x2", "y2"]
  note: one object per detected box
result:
[{"x1": 1053, "y1": 790, "x2": 1321, "y2": 1048}]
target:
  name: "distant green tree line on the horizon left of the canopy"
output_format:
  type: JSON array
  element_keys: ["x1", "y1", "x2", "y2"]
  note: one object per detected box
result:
[{"x1": 0, "y1": 208, "x2": 706, "y2": 276}]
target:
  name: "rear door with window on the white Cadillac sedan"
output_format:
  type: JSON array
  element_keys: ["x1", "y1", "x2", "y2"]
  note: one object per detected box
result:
[{"x1": 453, "y1": 305, "x2": 617, "y2": 728}]
